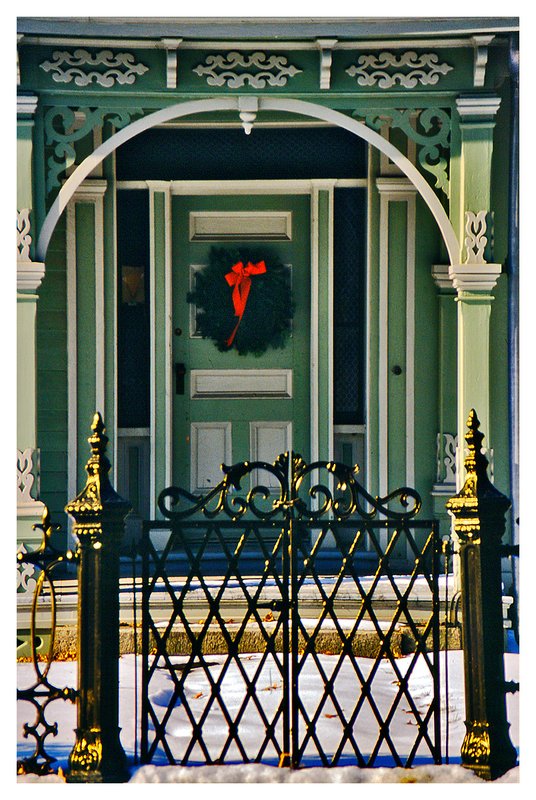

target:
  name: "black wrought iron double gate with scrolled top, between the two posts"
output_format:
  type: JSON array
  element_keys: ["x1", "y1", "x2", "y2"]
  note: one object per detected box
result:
[{"x1": 141, "y1": 453, "x2": 441, "y2": 767}]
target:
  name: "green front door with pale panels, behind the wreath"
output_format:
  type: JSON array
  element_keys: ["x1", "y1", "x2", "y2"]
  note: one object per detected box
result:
[{"x1": 170, "y1": 194, "x2": 311, "y2": 493}]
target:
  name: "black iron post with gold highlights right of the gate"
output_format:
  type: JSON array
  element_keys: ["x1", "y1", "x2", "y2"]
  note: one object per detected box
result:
[{"x1": 446, "y1": 409, "x2": 517, "y2": 780}]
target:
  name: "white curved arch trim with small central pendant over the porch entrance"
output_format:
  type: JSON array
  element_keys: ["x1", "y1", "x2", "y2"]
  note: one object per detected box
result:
[{"x1": 36, "y1": 95, "x2": 460, "y2": 265}]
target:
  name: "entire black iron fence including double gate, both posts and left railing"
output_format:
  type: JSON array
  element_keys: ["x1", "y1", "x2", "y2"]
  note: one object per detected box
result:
[{"x1": 19, "y1": 412, "x2": 517, "y2": 782}]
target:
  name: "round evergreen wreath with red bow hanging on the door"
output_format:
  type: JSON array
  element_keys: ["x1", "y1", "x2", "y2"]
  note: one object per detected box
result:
[{"x1": 187, "y1": 247, "x2": 294, "y2": 356}]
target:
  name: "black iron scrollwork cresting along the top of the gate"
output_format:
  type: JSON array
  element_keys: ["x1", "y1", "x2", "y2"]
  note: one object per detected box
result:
[{"x1": 158, "y1": 452, "x2": 422, "y2": 521}]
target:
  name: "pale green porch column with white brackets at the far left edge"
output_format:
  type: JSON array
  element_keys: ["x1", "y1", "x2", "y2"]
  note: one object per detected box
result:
[{"x1": 17, "y1": 96, "x2": 45, "y2": 548}]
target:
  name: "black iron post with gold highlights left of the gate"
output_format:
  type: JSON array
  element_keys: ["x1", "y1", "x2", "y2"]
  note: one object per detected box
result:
[{"x1": 65, "y1": 413, "x2": 130, "y2": 783}]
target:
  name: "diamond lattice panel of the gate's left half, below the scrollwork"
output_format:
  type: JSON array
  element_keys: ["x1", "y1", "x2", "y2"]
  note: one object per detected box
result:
[{"x1": 142, "y1": 522, "x2": 288, "y2": 763}]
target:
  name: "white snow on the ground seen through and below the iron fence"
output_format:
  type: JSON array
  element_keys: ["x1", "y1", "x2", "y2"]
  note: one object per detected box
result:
[{"x1": 17, "y1": 651, "x2": 519, "y2": 784}]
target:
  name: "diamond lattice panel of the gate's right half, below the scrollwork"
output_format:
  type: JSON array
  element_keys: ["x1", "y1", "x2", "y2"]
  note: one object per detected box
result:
[{"x1": 292, "y1": 522, "x2": 440, "y2": 767}]
